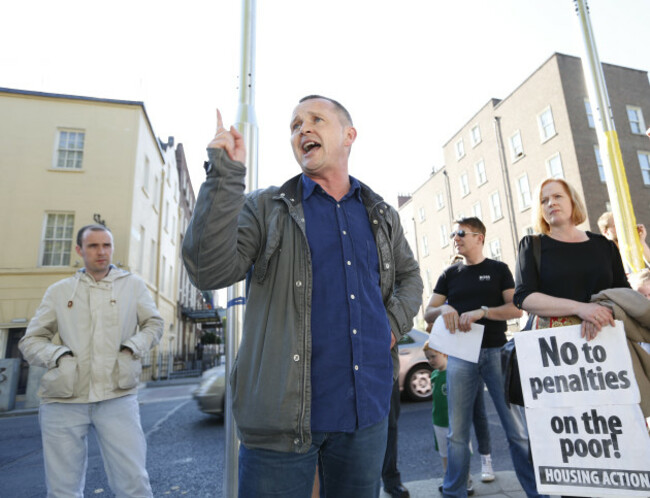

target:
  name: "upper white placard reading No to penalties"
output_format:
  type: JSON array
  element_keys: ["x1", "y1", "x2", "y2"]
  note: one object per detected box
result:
[{"x1": 514, "y1": 320, "x2": 641, "y2": 408}]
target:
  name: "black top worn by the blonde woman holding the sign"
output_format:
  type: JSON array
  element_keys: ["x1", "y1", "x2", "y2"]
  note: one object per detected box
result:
[{"x1": 514, "y1": 232, "x2": 630, "y2": 308}]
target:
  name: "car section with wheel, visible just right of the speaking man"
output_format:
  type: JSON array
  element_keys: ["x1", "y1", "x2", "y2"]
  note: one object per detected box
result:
[{"x1": 397, "y1": 329, "x2": 432, "y2": 401}]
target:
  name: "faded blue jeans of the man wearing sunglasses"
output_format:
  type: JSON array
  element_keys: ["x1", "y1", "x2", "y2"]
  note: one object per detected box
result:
[{"x1": 443, "y1": 348, "x2": 540, "y2": 497}]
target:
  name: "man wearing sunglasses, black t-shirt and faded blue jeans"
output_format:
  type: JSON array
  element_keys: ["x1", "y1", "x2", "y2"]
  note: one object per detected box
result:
[{"x1": 424, "y1": 217, "x2": 539, "y2": 497}]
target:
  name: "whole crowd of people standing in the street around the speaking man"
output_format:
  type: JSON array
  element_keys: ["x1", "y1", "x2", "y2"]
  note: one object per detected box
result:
[{"x1": 20, "y1": 95, "x2": 650, "y2": 498}]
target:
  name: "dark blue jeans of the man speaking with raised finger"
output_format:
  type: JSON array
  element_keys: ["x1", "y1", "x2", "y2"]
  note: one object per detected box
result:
[{"x1": 239, "y1": 418, "x2": 388, "y2": 498}]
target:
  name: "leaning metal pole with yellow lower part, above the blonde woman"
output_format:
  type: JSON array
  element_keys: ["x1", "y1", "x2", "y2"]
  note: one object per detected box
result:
[{"x1": 574, "y1": 0, "x2": 645, "y2": 271}]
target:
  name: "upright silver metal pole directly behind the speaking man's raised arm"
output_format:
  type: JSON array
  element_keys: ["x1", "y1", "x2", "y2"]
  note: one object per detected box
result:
[{"x1": 223, "y1": 0, "x2": 257, "y2": 498}]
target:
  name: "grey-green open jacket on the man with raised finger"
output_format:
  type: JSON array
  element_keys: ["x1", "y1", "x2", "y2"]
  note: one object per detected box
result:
[{"x1": 183, "y1": 149, "x2": 422, "y2": 453}]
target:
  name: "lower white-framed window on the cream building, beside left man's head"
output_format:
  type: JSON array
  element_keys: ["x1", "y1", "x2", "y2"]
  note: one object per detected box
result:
[{"x1": 38, "y1": 211, "x2": 75, "y2": 267}]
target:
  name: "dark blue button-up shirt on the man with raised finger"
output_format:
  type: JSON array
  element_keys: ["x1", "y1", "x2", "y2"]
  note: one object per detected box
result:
[{"x1": 302, "y1": 175, "x2": 393, "y2": 432}]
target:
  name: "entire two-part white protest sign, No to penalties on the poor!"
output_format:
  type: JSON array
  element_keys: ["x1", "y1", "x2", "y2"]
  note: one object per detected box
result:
[{"x1": 515, "y1": 321, "x2": 650, "y2": 496}]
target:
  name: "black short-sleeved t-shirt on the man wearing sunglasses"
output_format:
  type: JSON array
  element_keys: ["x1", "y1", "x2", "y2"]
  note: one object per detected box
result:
[{"x1": 433, "y1": 258, "x2": 515, "y2": 348}]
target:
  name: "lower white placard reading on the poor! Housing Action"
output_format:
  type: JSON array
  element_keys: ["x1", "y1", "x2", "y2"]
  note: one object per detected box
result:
[{"x1": 526, "y1": 405, "x2": 650, "y2": 496}]
